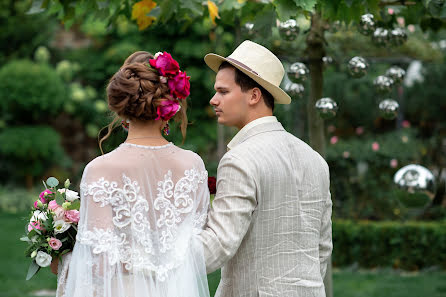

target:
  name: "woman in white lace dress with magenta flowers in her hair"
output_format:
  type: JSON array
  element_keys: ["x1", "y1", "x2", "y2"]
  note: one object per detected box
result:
[{"x1": 57, "y1": 52, "x2": 209, "y2": 297}]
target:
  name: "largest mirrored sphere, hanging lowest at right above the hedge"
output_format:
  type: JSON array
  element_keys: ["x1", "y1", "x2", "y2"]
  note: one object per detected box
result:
[{"x1": 393, "y1": 164, "x2": 435, "y2": 197}]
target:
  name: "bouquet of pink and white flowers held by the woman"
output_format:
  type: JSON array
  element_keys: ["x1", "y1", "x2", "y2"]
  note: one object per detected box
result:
[{"x1": 20, "y1": 177, "x2": 80, "y2": 280}]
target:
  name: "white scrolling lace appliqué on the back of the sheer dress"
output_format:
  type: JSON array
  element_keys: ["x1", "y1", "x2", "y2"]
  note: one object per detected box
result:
[{"x1": 77, "y1": 169, "x2": 207, "y2": 281}]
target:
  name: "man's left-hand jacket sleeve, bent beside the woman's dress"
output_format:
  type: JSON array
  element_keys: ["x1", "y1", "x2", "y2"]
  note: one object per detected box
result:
[{"x1": 199, "y1": 153, "x2": 257, "y2": 273}]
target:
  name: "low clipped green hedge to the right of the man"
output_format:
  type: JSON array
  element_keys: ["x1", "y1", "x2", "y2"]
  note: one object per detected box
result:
[{"x1": 332, "y1": 220, "x2": 446, "y2": 270}]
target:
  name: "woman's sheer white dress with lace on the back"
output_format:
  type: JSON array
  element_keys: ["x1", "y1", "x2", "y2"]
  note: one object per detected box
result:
[{"x1": 57, "y1": 143, "x2": 209, "y2": 297}]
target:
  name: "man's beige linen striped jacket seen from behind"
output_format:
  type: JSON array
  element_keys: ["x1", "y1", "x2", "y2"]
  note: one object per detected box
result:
[{"x1": 197, "y1": 117, "x2": 332, "y2": 297}]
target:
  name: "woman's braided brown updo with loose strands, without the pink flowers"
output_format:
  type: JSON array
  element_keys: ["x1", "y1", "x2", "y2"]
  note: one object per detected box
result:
[{"x1": 99, "y1": 51, "x2": 189, "y2": 150}]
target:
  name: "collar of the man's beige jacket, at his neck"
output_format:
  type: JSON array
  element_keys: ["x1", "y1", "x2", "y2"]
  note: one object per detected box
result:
[{"x1": 227, "y1": 116, "x2": 285, "y2": 151}]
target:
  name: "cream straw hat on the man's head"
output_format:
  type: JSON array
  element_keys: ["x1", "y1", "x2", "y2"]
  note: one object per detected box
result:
[{"x1": 204, "y1": 40, "x2": 291, "y2": 104}]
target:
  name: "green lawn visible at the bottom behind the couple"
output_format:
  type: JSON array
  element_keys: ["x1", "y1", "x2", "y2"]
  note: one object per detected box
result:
[{"x1": 0, "y1": 211, "x2": 446, "y2": 297}]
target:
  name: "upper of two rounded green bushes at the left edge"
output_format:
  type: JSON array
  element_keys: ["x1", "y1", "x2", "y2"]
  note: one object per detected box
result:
[{"x1": 0, "y1": 60, "x2": 67, "y2": 123}]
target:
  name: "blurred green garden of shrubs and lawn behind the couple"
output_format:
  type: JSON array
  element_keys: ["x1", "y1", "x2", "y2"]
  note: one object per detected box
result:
[{"x1": 0, "y1": 0, "x2": 446, "y2": 297}]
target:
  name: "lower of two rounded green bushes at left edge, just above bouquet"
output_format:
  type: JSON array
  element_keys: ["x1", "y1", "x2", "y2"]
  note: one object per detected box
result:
[{"x1": 0, "y1": 126, "x2": 71, "y2": 186}]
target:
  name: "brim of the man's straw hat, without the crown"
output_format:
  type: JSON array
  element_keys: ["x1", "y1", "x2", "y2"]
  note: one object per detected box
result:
[{"x1": 204, "y1": 54, "x2": 291, "y2": 104}]
